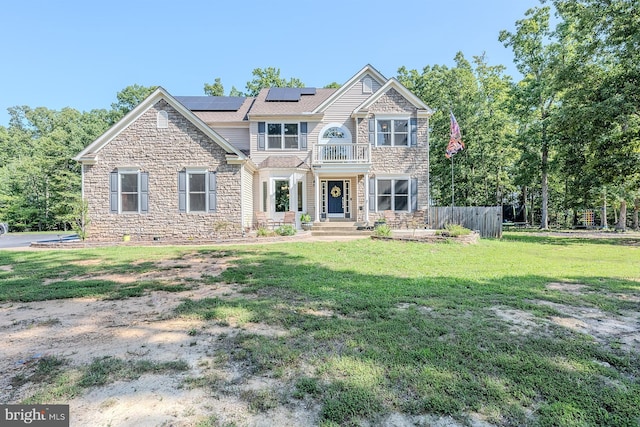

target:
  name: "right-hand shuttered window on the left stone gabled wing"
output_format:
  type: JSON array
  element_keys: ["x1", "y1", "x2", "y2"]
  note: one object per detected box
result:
[{"x1": 178, "y1": 170, "x2": 217, "y2": 213}]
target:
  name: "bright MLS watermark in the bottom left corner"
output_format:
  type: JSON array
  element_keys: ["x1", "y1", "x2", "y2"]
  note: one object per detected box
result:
[{"x1": 0, "y1": 405, "x2": 69, "y2": 427}]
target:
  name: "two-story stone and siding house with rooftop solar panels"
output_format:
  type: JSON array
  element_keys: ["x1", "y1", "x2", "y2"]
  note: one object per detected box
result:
[{"x1": 75, "y1": 65, "x2": 432, "y2": 240}]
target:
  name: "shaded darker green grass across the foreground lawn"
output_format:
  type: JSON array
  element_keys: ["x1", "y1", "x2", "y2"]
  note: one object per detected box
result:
[{"x1": 171, "y1": 250, "x2": 640, "y2": 426}]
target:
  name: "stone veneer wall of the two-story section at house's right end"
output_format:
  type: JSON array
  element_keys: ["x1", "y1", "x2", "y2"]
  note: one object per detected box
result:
[{"x1": 358, "y1": 89, "x2": 430, "y2": 226}]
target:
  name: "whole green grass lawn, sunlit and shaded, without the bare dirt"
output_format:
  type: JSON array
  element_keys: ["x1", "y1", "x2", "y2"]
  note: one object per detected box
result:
[{"x1": 0, "y1": 237, "x2": 640, "y2": 426}]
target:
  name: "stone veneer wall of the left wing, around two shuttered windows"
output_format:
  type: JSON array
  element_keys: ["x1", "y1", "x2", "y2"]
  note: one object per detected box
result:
[{"x1": 84, "y1": 100, "x2": 242, "y2": 240}]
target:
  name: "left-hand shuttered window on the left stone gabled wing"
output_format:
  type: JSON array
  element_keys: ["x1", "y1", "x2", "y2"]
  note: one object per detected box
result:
[{"x1": 109, "y1": 169, "x2": 149, "y2": 214}]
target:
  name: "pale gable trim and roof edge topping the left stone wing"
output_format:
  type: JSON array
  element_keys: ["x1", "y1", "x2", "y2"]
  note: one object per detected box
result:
[{"x1": 73, "y1": 87, "x2": 248, "y2": 162}]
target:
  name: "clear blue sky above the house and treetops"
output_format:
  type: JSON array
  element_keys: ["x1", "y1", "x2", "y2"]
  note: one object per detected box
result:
[{"x1": 0, "y1": 0, "x2": 540, "y2": 126}]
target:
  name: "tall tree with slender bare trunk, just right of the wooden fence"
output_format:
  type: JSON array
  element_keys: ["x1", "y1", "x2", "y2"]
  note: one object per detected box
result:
[{"x1": 499, "y1": 7, "x2": 562, "y2": 229}]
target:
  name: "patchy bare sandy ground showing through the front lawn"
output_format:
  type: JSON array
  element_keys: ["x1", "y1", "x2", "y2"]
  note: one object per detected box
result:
[{"x1": 0, "y1": 249, "x2": 640, "y2": 427}]
